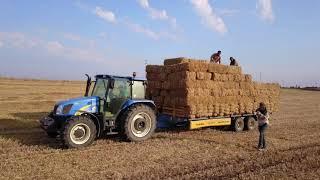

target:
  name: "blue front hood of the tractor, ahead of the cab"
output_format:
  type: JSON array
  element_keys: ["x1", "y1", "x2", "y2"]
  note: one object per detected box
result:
[{"x1": 54, "y1": 96, "x2": 99, "y2": 116}]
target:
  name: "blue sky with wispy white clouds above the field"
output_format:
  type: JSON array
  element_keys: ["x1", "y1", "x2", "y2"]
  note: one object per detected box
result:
[{"x1": 0, "y1": 0, "x2": 320, "y2": 86}]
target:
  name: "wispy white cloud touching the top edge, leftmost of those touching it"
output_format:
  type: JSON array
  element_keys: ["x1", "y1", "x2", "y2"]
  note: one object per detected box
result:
[{"x1": 138, "y1": 0, "x2": 177, "y2": 28}]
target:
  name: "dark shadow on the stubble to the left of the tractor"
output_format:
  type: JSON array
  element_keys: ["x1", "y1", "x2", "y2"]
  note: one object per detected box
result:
[{"x1": 0, "y1": 112, "x2": 61, "y2": 148}]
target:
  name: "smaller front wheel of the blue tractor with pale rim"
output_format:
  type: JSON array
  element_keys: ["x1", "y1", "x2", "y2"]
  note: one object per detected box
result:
[{"x1": 61, "y1": 116, "x2": 97, "y2": 148}]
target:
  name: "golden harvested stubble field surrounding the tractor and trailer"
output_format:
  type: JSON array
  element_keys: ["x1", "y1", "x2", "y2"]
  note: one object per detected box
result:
[{"x1": 0, "y1": 79, "x2": 320, "y2": 179}]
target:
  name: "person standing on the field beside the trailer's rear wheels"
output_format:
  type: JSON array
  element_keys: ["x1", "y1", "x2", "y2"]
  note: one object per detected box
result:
[{"x1": 255, "y1": 102, "x2": 269, "y2": 151}]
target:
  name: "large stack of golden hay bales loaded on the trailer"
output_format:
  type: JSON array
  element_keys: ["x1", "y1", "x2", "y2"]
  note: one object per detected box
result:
[{"x1": 146, "y1": 58, "x2": 280, "y2": 118}]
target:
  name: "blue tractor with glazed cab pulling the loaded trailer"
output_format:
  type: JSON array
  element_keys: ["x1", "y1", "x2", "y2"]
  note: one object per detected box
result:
[{"x1": 40, "y1": 74, "x2": 156, "y2": 148}]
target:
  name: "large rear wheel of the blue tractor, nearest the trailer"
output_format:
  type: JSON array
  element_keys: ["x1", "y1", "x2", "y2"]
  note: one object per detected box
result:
[{"x1": 120, "y1": 104, "x2": 156, "y2": 142}]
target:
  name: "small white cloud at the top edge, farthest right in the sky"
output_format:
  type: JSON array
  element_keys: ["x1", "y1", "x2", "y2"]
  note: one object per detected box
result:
[{"x1": 257, "y1": 0, "x2": 274, "y2": 23}]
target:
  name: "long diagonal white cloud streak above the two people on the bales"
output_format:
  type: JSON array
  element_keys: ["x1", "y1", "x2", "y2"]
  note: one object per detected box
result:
[{"x1": 190, "y1": 0, "x2": 228, "y2": 34}]
